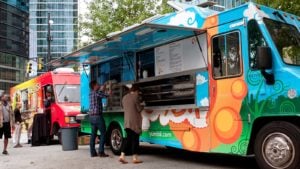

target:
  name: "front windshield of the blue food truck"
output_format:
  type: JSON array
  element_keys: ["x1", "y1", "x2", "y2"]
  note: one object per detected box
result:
[{"x1": 264, "y1": 18, "x2": 300, "y2": 65}]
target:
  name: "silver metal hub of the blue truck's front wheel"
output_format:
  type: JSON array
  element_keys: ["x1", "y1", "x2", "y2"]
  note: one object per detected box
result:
[{"x1": 262, "y1": 133, "x2": 295, "y2": 169}]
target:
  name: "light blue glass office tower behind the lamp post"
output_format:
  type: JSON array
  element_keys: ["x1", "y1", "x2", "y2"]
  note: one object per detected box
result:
[{"x1": 29, "y1": 0, "x2": 78, "y2": 62}]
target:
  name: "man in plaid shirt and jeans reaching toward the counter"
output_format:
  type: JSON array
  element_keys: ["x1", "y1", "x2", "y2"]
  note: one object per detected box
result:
[{"x1": 89, "y1": 80, "x2": 109, "y2": 157}]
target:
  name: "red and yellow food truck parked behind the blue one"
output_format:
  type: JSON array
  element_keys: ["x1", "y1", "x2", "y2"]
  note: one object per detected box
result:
[{"x1": 10, "y1": 68, "x2": 80, "y2": 140}]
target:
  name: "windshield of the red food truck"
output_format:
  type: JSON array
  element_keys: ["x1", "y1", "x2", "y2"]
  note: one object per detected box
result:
[{"x1": 55, "y1": 84, "x2": 80, "y2": 103}]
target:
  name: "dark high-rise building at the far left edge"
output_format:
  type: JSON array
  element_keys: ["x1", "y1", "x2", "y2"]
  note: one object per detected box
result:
[{"x1": 0, "y1": 0, "x2": 29, "y2": 92}]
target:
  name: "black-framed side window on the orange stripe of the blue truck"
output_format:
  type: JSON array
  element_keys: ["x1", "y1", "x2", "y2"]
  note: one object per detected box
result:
[{"x1": 212, "y1": 32, "x2": 241, "y2": 79}]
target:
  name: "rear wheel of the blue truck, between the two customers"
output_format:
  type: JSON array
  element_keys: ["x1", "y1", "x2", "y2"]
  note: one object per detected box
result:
[{"x1": 109, "y1": 125, "x2": 124, "y2": 155}]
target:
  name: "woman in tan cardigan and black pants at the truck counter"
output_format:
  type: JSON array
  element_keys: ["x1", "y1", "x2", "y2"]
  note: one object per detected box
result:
[{"x1": 119, "y1": 85, "x2": 143, "y2": 164}]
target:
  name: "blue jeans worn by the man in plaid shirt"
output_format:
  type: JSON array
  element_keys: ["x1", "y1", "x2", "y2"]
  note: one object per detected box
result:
[{"x1": 90, "y1": 115, "x2": 106, "y2": 156}]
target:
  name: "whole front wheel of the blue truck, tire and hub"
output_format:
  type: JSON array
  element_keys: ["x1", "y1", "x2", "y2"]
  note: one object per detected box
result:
[{"x1": 254, "y1": 122, "x2": 300, "y2": 169}]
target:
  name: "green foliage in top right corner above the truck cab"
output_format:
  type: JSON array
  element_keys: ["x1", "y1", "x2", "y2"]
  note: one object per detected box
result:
[{"x1": 256, "y1": 0, "x2": 300, "y2": 16}]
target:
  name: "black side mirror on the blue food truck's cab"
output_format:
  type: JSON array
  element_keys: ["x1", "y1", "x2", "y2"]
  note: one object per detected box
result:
[{"x1": 256, "y1": 46, "x2": 272, "y2": 70}]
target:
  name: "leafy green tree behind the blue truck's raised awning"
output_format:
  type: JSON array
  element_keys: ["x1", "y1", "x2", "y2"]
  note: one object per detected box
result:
[{"x1": 80, "y1": 0, "x2": 171, "y2": 41}]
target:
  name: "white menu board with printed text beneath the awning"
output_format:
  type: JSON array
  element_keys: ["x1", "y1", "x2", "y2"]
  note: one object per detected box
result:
[{"x1": 155, "y1": 37, "x2": 206, "y2": 76}]
